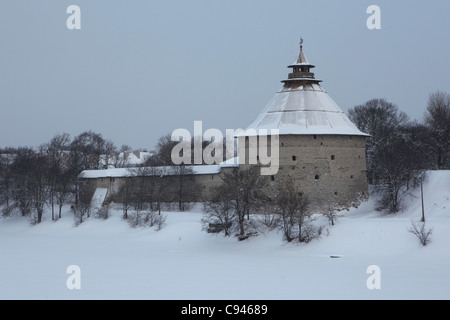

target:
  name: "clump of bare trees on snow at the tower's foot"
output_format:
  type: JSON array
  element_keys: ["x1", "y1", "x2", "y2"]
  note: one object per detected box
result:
[{"x1": 202, "y1": 166, "x2": 320, "y2": 242}]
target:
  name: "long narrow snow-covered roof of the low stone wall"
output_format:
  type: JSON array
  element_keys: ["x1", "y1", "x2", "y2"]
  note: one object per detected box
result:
[{"x1": 78, "y1": 158, "x2": 239, "y2": 179}]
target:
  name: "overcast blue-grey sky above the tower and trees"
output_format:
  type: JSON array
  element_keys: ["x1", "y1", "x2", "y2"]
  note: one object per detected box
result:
[{"x1": 0, "y1": 0, "x2": 450, "y2": 149}]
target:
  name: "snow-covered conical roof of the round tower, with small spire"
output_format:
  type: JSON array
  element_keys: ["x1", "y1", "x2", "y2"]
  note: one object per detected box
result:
[{"x1": 244, "y1": 42, "x2": 369, "y2": 136}]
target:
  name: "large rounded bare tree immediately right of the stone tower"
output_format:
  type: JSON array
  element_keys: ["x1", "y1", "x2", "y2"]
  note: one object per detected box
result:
[{"x1": 349, "y1": 99, "x2": 428, "y2": 213}]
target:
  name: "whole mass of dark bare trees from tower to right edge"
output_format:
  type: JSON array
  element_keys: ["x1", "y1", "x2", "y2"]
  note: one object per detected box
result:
[{"x1": 348, "y1": 91, "x2": 450, "y2": 213}]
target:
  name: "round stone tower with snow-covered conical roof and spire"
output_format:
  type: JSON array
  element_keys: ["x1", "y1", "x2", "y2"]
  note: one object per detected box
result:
[{"x1": 238, "y1": 41, "x2": 368, "y2": 207}]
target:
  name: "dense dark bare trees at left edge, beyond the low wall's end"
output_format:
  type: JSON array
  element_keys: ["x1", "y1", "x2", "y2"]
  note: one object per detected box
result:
[{"x1": 0, "y1": 131, "x2": 117, "y2": 223}]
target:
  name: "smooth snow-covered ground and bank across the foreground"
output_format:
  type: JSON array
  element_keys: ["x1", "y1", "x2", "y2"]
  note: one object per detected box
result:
[{"x1": 0, "y1": 171, "x2": 450, "y2": 299}]
